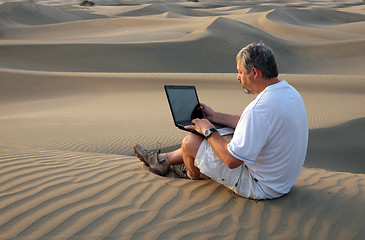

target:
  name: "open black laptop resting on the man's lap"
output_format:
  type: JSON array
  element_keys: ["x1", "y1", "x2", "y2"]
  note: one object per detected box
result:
[{"x1": 164, "y1": 85, "x2": 234, "y2": 136}]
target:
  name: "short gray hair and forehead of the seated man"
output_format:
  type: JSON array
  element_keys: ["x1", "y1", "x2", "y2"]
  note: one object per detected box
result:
[{"x1": 236, "y1": 43, "x2": 279, "y2": 79}]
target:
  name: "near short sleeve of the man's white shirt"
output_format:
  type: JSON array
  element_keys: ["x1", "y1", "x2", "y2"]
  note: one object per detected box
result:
[{"x1": 227, "y1": 109, "x2": 270, "y2": 163}]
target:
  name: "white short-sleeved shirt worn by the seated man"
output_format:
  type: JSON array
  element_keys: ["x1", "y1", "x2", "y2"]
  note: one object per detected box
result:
[{"x1": 227, "y1": 81, "x2": 308, "y2": 198}]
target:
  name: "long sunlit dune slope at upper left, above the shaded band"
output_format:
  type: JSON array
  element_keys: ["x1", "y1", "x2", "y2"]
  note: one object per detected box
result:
[{"x1": 1, "y1": 17, "x2": 206, "y2": 45}]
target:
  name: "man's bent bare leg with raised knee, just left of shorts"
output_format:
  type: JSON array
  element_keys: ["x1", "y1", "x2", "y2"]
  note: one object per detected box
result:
[{"x1": 181, "y1": 133, "x2": 204, "y2": 179}]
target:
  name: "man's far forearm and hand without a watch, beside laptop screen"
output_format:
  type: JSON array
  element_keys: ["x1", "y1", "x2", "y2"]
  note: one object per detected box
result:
[{"x1": 200, "y1": 103, "x2": 240, "y2": 128}]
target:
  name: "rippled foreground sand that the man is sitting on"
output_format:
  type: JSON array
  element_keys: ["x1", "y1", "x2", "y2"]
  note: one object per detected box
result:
[{"x1": 0, "y1": 149, "x2": 365, "y2": 239}]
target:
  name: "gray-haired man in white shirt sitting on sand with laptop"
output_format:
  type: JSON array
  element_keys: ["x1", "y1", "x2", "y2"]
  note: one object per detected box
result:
[{"x1": 133, "y1": 44, "x2": 308, "y2": 199}]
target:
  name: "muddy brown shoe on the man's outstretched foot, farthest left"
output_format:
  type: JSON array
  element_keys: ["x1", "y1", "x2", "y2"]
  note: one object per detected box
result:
[{"x1": 133, "y1": 144, "x2": 170, "y2": 176}]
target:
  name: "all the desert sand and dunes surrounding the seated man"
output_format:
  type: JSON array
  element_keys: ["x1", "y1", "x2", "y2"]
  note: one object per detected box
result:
[{"x1": 0, "y1": 0, "x2": 365, "y2": 239}]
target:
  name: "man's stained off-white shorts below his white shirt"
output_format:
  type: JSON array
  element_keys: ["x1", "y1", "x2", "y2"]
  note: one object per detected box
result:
[{"x1": 194, "y1": 135, "x2": 267, "y2": 199}]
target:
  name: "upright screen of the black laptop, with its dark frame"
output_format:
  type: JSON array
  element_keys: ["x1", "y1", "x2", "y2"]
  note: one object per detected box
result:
[{"x1": 165, "y1": 85, "x2": 203, "y2": 125}]
